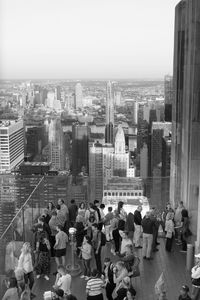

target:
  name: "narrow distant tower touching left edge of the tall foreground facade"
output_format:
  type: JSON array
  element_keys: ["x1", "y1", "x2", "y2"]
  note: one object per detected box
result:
[{"x1": 164, "y1": 75, "x2": 174, "y2": 122}]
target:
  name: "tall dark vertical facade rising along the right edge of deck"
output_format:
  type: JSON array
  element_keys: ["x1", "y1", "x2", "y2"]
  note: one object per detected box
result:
[{"x1": 170, "y1": 0, "x2": 200, "y2": 239}]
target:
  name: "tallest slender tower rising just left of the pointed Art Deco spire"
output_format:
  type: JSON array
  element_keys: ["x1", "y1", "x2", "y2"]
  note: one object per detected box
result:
[{"x1": 105, "y1": 81, "x2": 114, "y2": 144}]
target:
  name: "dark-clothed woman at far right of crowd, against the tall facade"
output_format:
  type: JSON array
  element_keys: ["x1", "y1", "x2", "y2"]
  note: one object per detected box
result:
[{"x1": 181, "y1": 209, "x2": 191, "y2": 252}]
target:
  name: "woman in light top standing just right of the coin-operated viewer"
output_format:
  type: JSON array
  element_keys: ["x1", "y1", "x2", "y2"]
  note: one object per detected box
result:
[{"x1": 80, "y1": 235, "x2": 92, "y2": 280}]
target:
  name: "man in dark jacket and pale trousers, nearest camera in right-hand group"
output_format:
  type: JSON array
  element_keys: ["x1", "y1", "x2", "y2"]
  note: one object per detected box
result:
[{"x1": 141, "y1": 211, "x2": 154, "y2": 260}]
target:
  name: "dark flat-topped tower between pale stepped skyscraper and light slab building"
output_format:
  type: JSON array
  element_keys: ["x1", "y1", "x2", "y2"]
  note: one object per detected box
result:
[{"x1": 72, "y1": 124, "x2": 90, "y2": 177}]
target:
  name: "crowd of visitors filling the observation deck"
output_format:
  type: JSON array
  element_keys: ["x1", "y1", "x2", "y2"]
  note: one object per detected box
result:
[{"x1": 3, "y1": 199, "x2": 200, "y2": 300}]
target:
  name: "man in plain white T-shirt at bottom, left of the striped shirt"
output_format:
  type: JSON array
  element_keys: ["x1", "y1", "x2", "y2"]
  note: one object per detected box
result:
[{"x1": 54, "y1": 265, "x2": 72, "y2": 295}]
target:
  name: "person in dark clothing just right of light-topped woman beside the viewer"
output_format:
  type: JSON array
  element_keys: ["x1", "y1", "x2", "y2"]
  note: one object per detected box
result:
[{"x1": 92, "y1": 223, "x2": 102, "y2": 274}]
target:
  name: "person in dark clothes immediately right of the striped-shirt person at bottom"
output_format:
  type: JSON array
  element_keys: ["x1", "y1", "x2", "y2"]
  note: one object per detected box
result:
[{"x1": 104, "y1": 257, "x2": 116, "y2": 300}]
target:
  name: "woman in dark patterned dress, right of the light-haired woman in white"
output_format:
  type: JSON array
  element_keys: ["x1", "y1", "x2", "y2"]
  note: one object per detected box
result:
[{"x1": 35, "y1": 225, "x2": 51, "y2": 280}]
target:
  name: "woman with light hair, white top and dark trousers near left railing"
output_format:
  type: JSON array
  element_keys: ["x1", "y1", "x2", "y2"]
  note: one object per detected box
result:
[{"x1": 17, "y1": 242, "x2": 35, "y2": 297}]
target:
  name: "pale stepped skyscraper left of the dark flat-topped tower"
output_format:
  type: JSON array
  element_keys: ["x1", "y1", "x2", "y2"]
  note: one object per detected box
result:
[{"x1": 49, "y1": 119, "x2": 65, "y2": 170}]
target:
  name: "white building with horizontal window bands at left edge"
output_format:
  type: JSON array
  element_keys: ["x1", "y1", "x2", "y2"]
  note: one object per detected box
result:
[{"x1": 0, "y1": 120, "x2": 24, "y2": 172}]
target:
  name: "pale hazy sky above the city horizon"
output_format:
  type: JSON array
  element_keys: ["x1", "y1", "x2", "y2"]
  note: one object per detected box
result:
[{"x1": 0, "y1": 0, "x2": 179, "y2": 78}]
